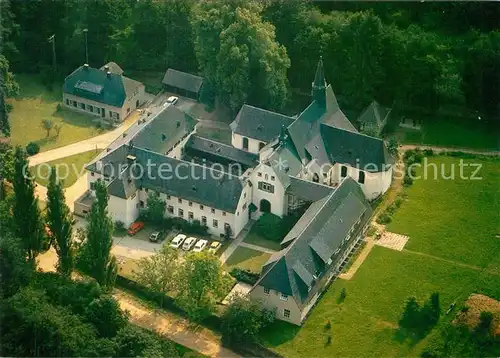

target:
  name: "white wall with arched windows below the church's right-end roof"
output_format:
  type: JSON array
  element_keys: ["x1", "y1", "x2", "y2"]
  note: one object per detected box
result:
[{"x1": 328, "y1": 163, "x2": 392, "y2": 200}]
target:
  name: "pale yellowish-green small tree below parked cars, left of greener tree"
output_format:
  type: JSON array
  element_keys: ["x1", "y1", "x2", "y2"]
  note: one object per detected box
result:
[{"x1": 134, "y1": 244, "x2": 179, "y2": 306}]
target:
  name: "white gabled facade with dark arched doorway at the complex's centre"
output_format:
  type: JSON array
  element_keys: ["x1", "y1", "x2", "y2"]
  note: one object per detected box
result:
[{"x1": 250, "y1": 164, "x2": 286, "y2": 216}]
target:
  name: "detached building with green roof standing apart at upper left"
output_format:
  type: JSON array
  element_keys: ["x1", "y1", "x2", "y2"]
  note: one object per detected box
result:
[{"x1": 63, "y1": 62, "x2": 145, "y2": 122}]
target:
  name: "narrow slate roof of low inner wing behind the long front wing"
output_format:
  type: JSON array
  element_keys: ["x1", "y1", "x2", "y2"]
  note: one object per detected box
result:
[{"x1": 185, "y1": 135, "x2": 259, "y2": 167}]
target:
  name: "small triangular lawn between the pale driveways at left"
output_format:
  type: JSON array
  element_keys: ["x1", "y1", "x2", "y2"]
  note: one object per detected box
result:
[{"x1": 31, "y1": 150, "x2": 99, "y2": 188}]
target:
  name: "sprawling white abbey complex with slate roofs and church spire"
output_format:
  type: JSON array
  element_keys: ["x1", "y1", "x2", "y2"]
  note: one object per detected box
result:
[{"x1": 75, "y1": 60, "x2": 394, "y2": 324}]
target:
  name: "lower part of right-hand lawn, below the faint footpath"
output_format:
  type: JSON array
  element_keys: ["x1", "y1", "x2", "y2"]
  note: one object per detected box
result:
[{"x1": 263, "y1": 246, "x2": 500, "y2": 357}]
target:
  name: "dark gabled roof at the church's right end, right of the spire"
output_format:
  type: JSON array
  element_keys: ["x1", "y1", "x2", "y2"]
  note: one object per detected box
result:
[{"x1": 321, "y1": 124, "x2": 394, "y2": 172}]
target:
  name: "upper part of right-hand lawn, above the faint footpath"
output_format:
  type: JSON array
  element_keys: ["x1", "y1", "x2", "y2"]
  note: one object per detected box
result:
[{"x1": 387, "y1": 156, "x2": 500, "y2": 272}]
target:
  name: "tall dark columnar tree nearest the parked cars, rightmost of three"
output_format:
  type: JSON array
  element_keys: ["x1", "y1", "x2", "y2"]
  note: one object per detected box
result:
[{"x1": 79, "y1": 180, "x2": 116, "y2": 289}]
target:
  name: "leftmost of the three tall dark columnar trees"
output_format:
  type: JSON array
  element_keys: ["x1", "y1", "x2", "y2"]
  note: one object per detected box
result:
[{"x1": 12, "y1": 147, "x2": 48, "y2": 267}]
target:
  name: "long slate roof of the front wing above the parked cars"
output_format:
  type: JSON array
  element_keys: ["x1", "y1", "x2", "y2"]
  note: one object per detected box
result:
[{"x1": 89, "y1": 145, "x2": 243, "y2": 213}]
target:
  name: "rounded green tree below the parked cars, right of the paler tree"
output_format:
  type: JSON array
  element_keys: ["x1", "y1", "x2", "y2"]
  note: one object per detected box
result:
[{"x1": 175, "y1": 252, "x2": 222, "y2": 321}]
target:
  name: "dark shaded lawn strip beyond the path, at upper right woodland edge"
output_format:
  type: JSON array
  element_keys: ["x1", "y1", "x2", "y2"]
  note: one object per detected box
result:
[{"x1": 398, "y1": 118, "x2": 500, "y2": 150}]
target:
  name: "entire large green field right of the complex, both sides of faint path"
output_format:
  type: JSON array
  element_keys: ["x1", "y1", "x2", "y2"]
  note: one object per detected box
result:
[{"x1": 262, "y1": 156, "x2": 500, "y2": 357}]
